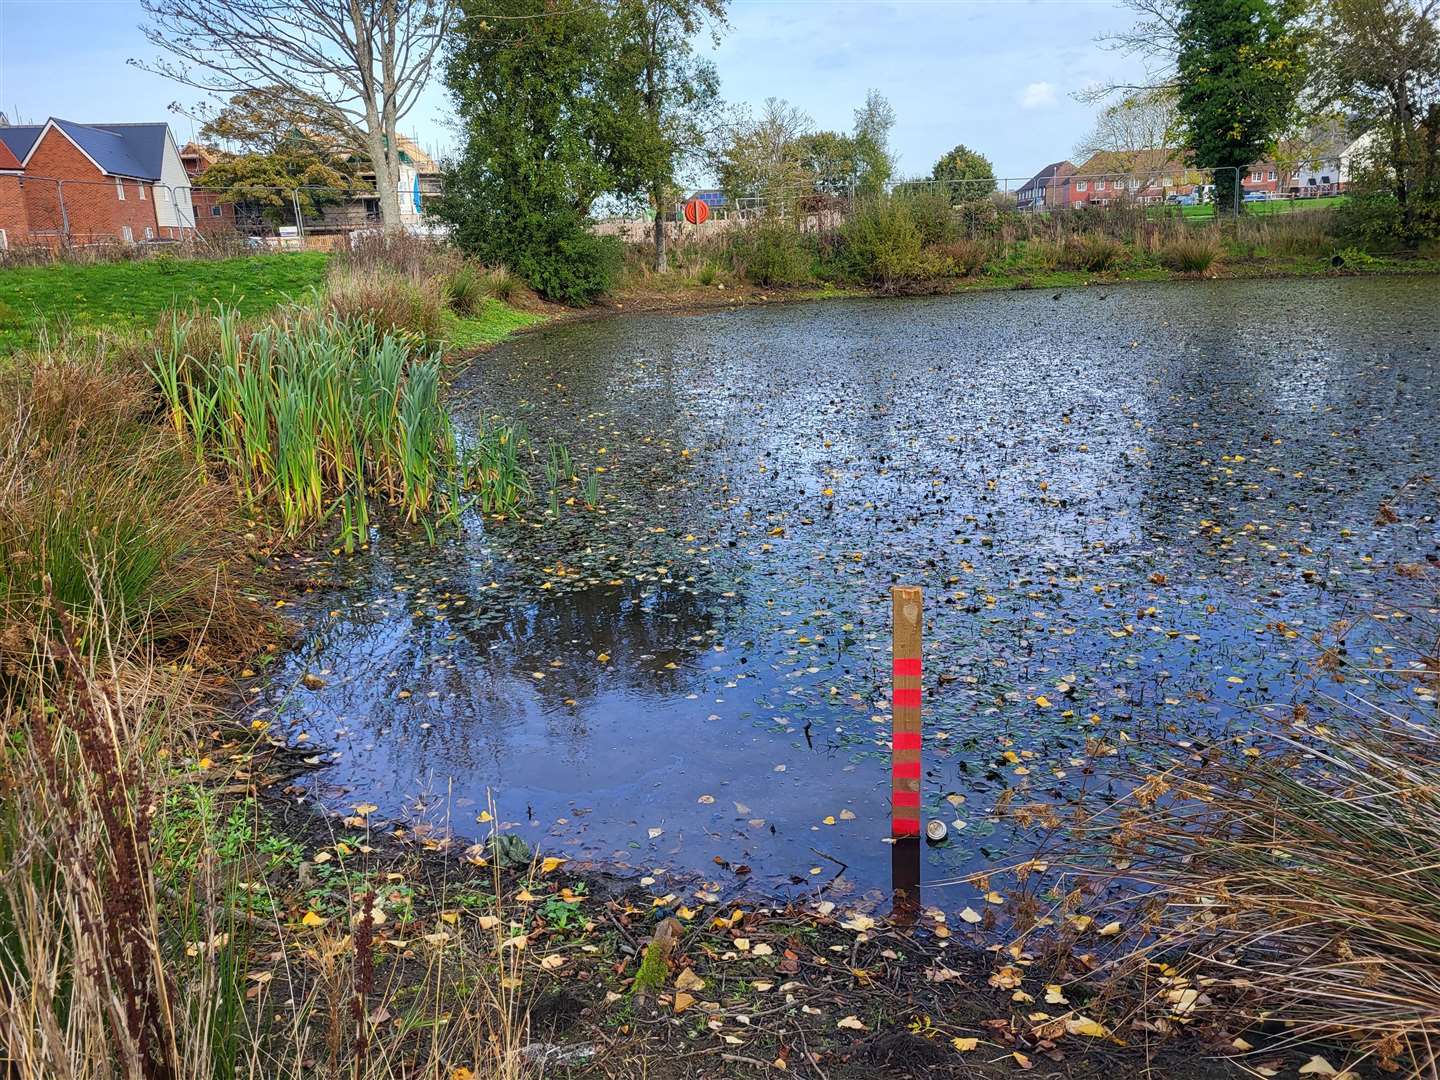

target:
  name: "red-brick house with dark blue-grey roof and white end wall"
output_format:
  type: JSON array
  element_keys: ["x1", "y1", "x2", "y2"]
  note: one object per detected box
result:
[{"x1": 0, "y1": 117, "x2": 194, "y2": 246}]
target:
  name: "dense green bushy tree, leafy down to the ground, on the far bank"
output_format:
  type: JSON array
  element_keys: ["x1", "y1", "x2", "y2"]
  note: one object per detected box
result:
[{"x1": 433, "y1": 0, "x2": 633, "y2": 302}]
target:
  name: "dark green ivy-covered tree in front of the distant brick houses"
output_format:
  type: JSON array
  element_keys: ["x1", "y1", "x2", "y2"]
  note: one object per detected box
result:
[{"x1": 1175, "y1": 0, "x2": 1306, "y2": 207}]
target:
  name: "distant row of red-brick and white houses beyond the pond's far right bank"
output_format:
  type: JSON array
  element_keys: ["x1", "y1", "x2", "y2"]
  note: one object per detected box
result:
[{"x1": 1015, "y1": 134, "x2": 1371, "y2": 210}]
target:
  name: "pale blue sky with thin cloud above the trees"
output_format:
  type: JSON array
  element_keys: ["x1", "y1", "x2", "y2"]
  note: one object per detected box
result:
[{"x1": 0, "y1": 0, "x2": 1130, "y2": 176}]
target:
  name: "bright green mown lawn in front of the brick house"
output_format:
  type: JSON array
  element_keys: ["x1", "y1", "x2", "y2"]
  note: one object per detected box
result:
[{"x1": 0, "y1": 252, "x2": 328, "y2": 353}]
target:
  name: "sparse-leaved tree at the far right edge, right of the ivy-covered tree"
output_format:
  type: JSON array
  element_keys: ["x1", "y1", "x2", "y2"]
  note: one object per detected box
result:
[{"x1": 1315, "y1": 0, "x2": 1440, "y2": 240}]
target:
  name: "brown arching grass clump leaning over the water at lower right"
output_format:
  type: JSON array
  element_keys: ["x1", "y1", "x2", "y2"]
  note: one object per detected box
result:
[{"x1": 1090, "y1": 563, "x2": 1440, "y2": 1076}]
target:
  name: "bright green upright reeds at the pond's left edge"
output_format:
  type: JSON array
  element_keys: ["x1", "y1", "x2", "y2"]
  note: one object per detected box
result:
[{"x1": 150, "y1": 311, "x2": 528, "y2": 550}]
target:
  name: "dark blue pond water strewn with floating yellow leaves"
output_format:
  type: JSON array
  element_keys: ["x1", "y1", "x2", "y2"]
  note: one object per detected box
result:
[{"x1": 252, "y1": 278, "x2": 1440, "y2": 906}]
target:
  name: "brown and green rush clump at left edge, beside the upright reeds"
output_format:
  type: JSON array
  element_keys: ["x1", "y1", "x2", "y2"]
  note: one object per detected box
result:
[{"x1": 0, "y1": 340, "x2": 262, "y2": 671}]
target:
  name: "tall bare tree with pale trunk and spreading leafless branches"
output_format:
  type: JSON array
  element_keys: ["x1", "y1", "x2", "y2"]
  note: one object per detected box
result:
[{"x1": 131, "y1": 0, "x2": 454, "y2": 229}]
